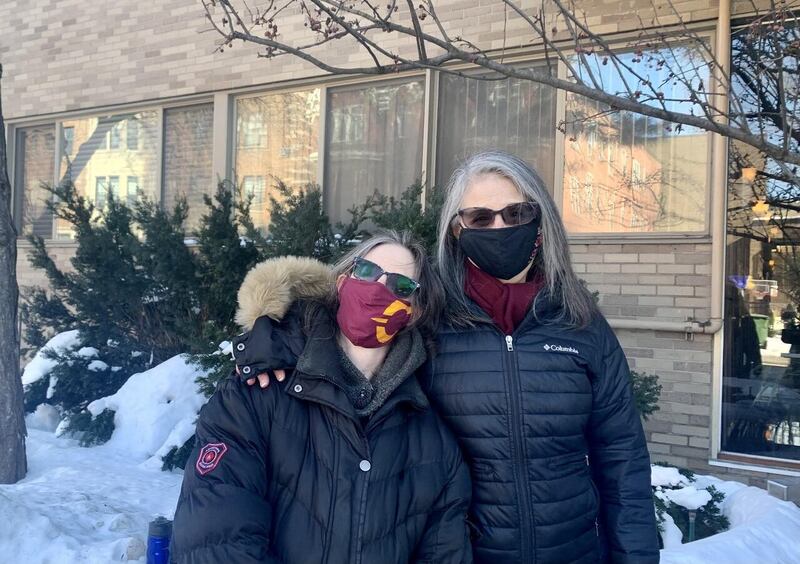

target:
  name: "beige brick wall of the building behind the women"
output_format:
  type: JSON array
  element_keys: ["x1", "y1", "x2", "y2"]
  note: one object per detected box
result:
[{"x1": 0, "y1": 0, "x2": 796, "y2": 484}]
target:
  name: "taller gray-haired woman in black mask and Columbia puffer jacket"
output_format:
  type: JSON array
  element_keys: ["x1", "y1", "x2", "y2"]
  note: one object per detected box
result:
[{"x1": 233, "y1": 151, "x2": 659, "y2": 564}]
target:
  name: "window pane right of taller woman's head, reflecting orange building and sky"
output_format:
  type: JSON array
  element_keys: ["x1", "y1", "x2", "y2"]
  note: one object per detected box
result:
[{"x1": 563, "y1": 48, "x2": 709, "y2": 233}]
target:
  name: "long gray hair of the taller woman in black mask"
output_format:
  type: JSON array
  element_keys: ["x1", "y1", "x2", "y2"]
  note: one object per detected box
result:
[{"x1": 436, "y1": 151, "x2": 597, "y2": 327}]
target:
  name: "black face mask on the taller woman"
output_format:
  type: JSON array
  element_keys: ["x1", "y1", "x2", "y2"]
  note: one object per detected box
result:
[{"x1": 458, "y1": 220, "x2": 541, "y2": 280}]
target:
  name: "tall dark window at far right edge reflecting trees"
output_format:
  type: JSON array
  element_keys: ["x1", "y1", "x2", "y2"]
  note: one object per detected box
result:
[{"x1": 722, "y1": 21, "x2": 800, "y2": 460}]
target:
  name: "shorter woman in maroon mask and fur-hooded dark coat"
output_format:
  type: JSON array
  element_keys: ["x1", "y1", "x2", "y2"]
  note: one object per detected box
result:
[{"x1": 173, "y1": 233, "x2": 472, "y2": 564}]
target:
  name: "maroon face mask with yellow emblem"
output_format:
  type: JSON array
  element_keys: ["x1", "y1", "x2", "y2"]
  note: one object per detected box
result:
[{"x1": 336, "y1": 277, "x2": 412, "y2": 349}]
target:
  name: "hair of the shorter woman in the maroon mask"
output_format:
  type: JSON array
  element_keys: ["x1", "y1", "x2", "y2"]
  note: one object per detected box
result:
[{"x1": 316, "y1": 230, "x2": 444, "y2": 338}]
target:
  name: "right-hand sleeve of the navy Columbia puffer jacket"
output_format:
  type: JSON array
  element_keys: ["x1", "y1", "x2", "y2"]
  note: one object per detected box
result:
[{"x1": 589, "y1": 319, "x2": 659, "y2": 563}]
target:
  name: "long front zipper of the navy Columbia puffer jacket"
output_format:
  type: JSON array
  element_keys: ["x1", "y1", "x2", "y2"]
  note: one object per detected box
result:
[{"x1": 506, "y1": 335, "x2": 536, "y2": 562}]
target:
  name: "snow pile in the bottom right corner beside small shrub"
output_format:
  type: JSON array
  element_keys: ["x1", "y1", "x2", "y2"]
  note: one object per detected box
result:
[{"x1": 661, "y1": 475, "x2": 800, "y2": 564}]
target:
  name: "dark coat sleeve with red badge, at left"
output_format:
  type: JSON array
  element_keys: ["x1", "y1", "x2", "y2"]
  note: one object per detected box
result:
[{"x1": 170, "y1": 378, "x2": 280, "y2": 564}]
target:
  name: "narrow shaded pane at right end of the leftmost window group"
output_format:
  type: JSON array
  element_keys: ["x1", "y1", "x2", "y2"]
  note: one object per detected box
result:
[{"x1": 162, "y1": 104, "x2": 215, "y2": 233}]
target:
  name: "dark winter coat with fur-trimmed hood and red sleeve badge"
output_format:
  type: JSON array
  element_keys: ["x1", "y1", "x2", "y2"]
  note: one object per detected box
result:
[{"x1": 172, "y1": 259, "x2": 472, "y2": 564}]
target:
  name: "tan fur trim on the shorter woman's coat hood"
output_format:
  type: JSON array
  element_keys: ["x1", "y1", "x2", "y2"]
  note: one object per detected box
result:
[{"x1": 236, "y1": 256, "x2": 333, "y2": 331}]
